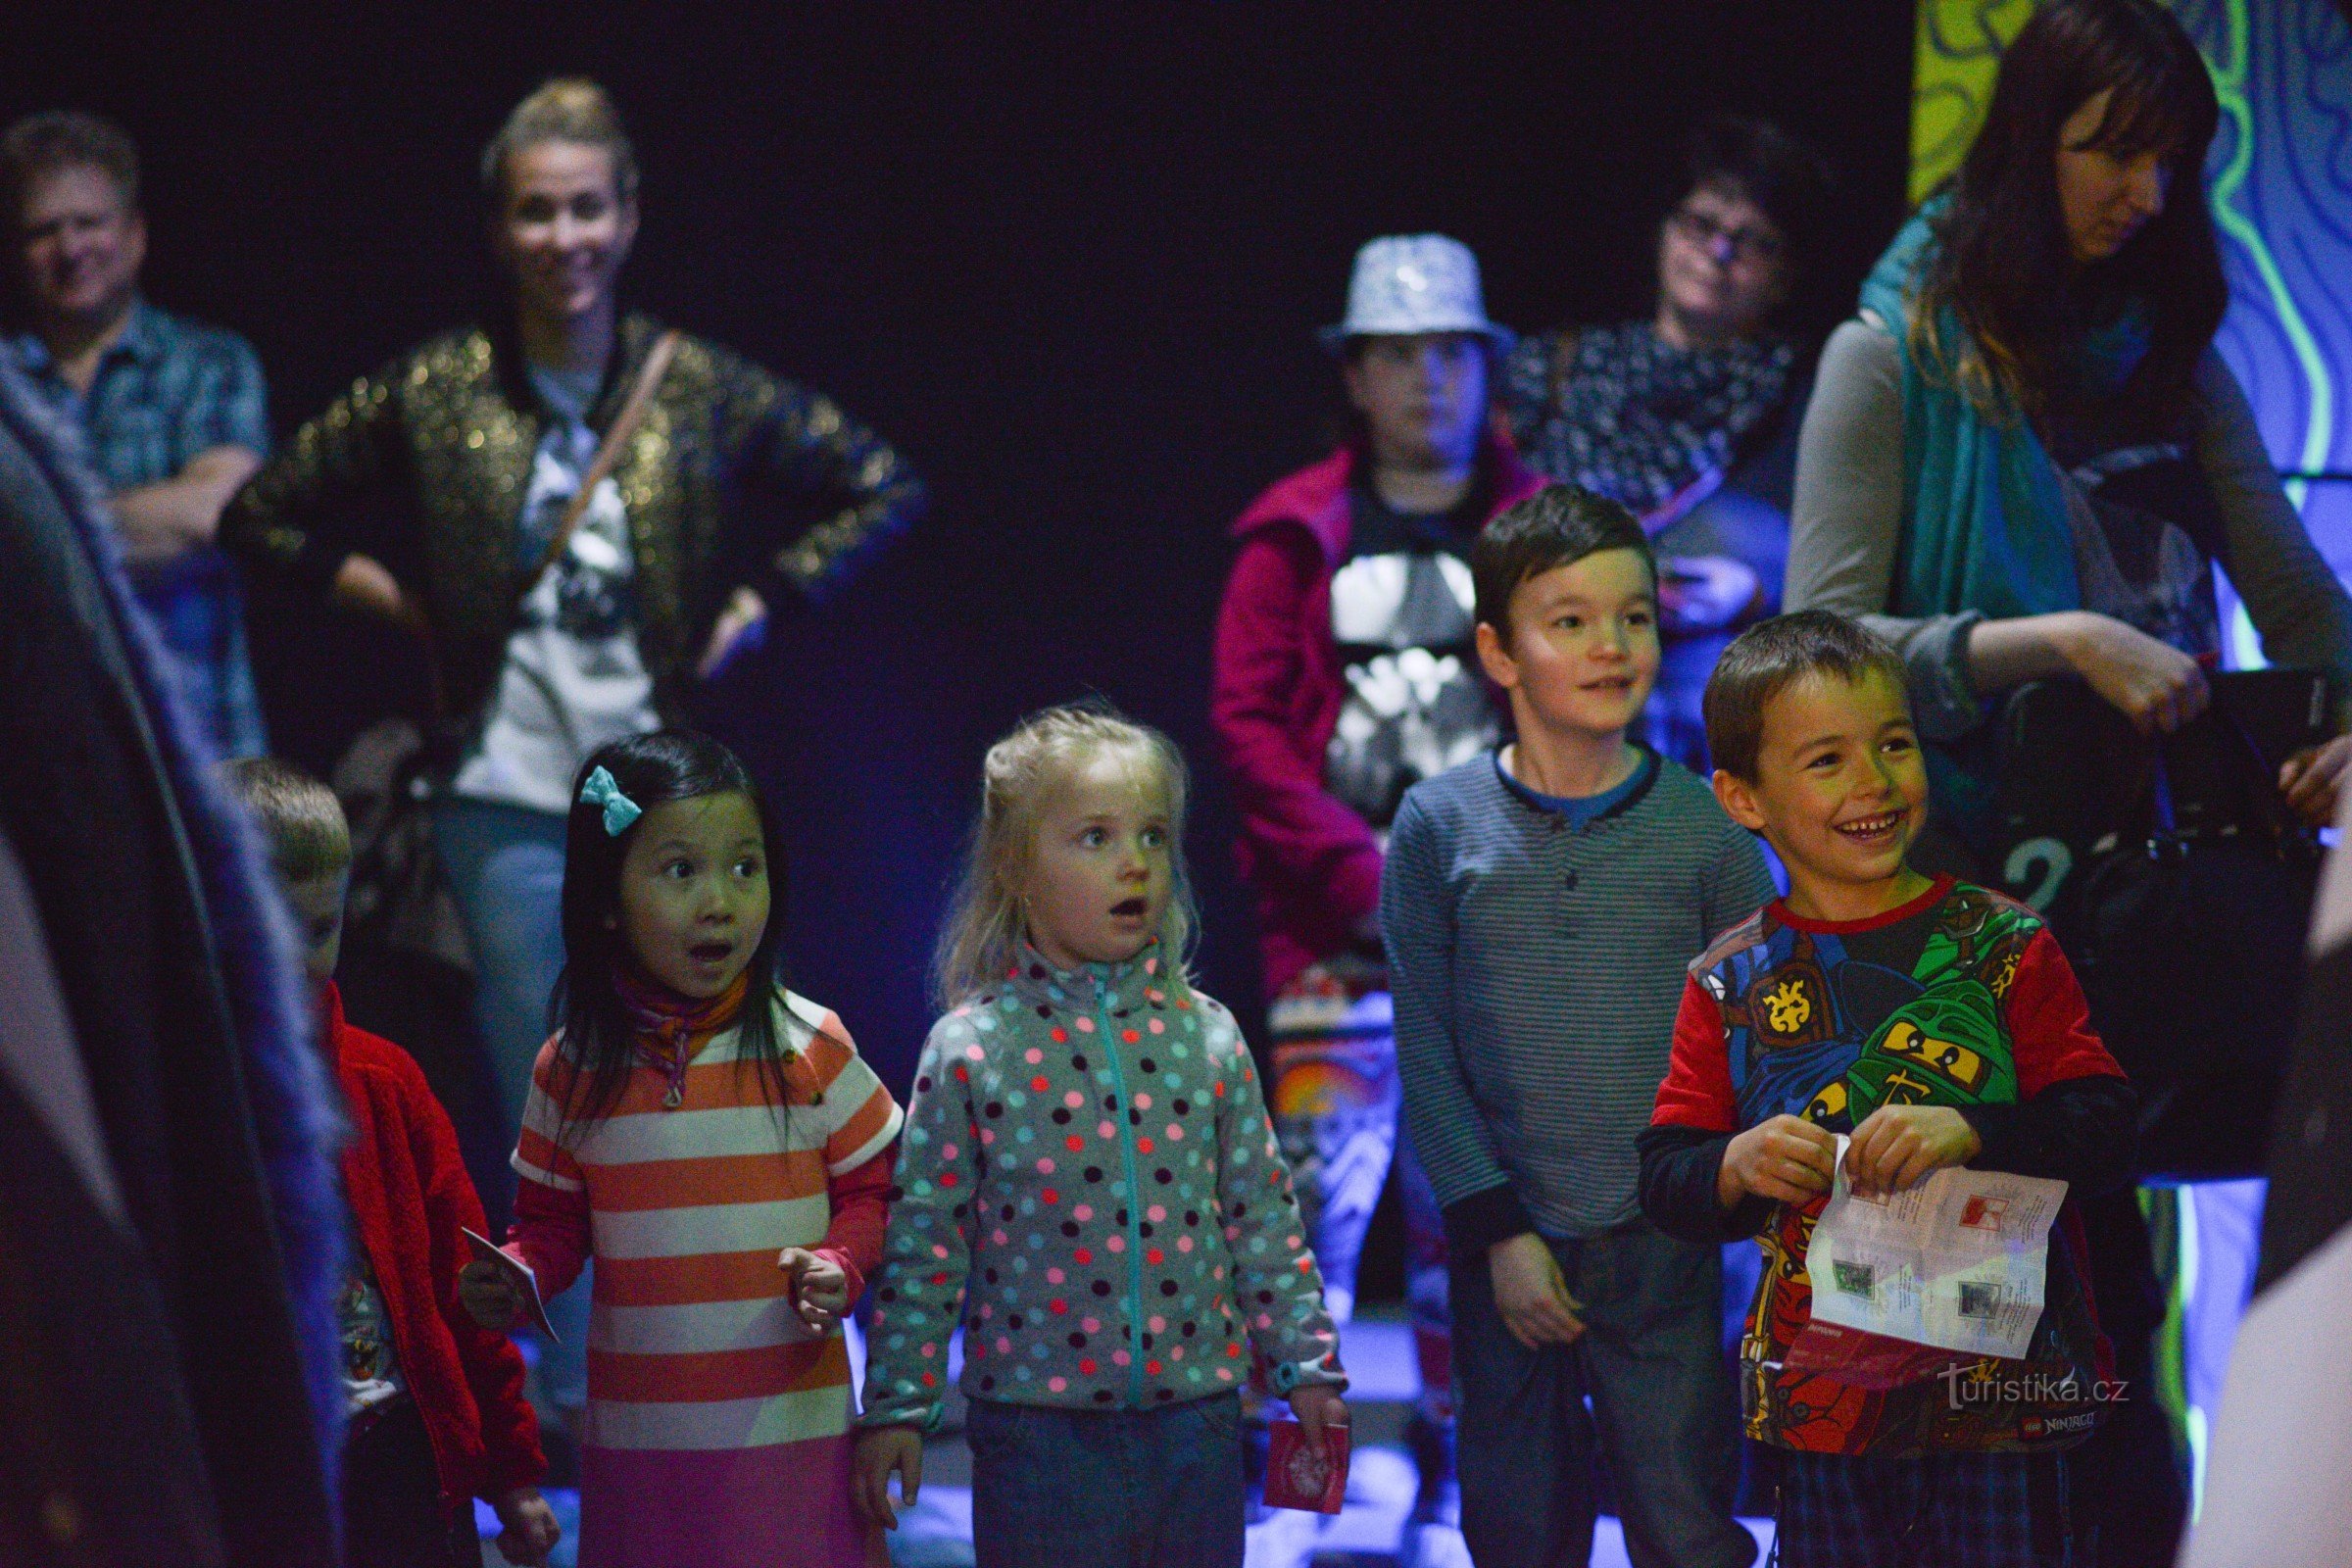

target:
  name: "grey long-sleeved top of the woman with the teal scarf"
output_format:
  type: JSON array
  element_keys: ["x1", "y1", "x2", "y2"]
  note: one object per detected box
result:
[{"x1": 1783, "y1": 318, "x2": 2352, "y2": 741}]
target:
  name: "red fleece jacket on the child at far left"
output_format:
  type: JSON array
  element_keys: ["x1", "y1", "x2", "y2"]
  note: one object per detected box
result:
[{"x1": 322, "y1": 985, "x2": 548, "y2": 1516}]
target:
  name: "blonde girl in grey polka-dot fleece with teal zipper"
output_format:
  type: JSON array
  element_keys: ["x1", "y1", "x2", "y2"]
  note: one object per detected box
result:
[{"x1": 857, "y1": 706, "x2": 1346, "y2": 1568}]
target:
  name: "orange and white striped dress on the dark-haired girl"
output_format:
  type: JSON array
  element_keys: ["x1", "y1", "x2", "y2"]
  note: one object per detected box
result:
[{"x1": 511, "y1": 990, "x2": 901, "y2": 1568}]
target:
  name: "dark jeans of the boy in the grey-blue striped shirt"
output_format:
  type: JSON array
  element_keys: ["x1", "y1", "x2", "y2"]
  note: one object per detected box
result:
[{"x1": 1453, "y1": 1222, "x2": 1754, "y2": 1568}]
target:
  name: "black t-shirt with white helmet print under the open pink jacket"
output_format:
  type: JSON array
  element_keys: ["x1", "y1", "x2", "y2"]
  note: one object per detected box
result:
[{"x1": 1324, "y1": 475, "x2": 1500, "y2": 839}]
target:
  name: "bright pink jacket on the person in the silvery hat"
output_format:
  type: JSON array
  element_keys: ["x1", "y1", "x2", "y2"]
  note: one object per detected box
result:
[{"x1": 1209, "y1": 430, "x2": 1543, "y2": 995}]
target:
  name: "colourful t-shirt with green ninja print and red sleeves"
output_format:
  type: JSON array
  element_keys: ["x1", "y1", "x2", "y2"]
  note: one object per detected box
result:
[{"x1": 1656, "y1": 879, "x2": 2122, "y2": 1455}]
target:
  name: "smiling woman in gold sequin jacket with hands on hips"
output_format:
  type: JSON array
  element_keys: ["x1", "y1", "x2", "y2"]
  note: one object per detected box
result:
[{"x1": 221, "y1": 80, "x2": 922, "y2": 1422}]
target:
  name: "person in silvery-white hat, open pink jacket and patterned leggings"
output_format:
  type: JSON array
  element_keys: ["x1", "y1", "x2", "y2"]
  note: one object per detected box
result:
[{"x1": 1211, "y1": 235, "x2": 1539, "y2": 1560}]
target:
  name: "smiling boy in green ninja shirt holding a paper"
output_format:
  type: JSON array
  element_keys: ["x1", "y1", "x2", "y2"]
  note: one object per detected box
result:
[{"x1": 1640, "y1": 612, "x2": 2133, "y2": 1568}]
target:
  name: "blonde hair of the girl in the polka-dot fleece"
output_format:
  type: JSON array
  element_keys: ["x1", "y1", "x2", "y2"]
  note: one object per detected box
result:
[{"x1": 931, "y1": 703, "x2": 1198, "y2": 1006}]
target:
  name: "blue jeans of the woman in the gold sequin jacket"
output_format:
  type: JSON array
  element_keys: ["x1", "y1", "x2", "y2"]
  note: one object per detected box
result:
[{"x1": 433, "y1": 795, "x2": 590, "y2": 1408}]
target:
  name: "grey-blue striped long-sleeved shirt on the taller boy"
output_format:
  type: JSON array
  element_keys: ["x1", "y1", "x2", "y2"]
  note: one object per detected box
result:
[{"x1": 1381, "y1": 753, "x2": 1776, "y2": 1260}]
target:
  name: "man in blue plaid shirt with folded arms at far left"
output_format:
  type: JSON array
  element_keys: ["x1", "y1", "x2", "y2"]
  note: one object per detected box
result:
[{"x1": 0, "y1": 113, "x2": 269, "y2": 757}]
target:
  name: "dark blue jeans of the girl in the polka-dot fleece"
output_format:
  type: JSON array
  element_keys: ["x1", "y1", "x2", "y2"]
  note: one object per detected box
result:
[{"x1": 964, "y1": 1394, "x2": 1245, "y2": 1568}]
